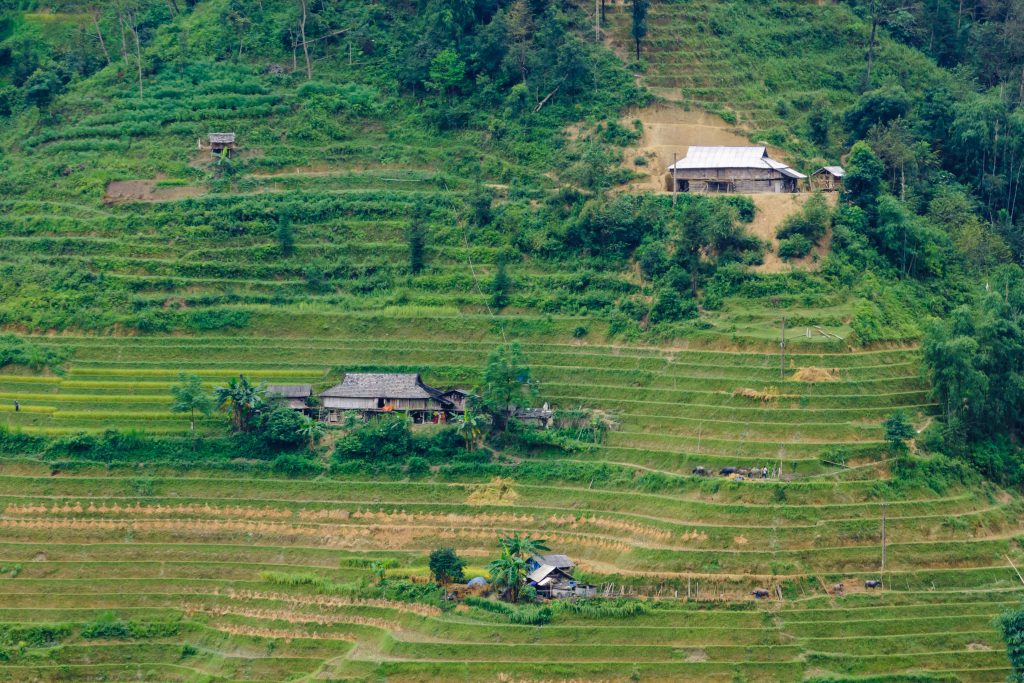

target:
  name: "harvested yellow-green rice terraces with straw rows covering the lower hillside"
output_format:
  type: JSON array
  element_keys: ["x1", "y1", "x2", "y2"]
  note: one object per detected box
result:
[{"x1": 0, "y1": 327, "x2": 1024, "y2": 681}]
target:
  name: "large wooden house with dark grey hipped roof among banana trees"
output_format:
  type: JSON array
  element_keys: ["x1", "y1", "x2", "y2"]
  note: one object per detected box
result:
[{"x1": 319, "y1": 373, "x2": 454, "y2": 422}]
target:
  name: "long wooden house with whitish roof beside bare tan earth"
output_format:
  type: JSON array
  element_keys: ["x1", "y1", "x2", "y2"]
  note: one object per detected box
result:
[{"x1": 669, "y1": 146, "x2": 807, "y2": 194}]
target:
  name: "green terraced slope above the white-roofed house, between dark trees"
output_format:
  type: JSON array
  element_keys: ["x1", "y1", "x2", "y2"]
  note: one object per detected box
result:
[{"x1": 605, "y1": 0, "x2": 944, "y2": 161}]
